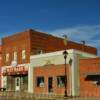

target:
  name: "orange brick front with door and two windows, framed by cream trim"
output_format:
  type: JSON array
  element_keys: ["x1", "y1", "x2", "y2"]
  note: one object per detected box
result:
[{"x1": 33, "y1": 65, "x2": 70, "y2": 96}]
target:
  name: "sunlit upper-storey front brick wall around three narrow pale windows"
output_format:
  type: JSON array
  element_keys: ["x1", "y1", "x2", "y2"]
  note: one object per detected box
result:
[{"x1": 2, "y1": 31, "x2": 30, "y2": 66}]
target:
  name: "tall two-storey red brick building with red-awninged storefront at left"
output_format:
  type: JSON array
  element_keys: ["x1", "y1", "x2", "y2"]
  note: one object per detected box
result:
[{"x1": 1, "y1": 30, "x2": 97, "y2": 95}]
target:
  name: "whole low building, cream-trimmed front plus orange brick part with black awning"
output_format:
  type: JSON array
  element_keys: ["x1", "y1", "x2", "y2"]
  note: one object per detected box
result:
[{"x1": 30, "y1": 49, "x2": 100, "y2": 97}]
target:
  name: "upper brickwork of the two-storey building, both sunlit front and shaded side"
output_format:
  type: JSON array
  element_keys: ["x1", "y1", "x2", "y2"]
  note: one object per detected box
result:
[{"x1": 2, "y1": 30, "x2": 97, "y2": 66}]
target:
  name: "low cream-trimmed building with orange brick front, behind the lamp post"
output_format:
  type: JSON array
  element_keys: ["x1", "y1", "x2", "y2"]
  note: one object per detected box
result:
[{"x1": 29, "y1": 49, "x2": 97, "y2": 96}]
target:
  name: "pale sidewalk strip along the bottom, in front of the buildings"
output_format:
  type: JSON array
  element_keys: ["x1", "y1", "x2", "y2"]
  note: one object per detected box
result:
[{"x1": 0, "y1": 92, "x2": 100, "y2": 100}]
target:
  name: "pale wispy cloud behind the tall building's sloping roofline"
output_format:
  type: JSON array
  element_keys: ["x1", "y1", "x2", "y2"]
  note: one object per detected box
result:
[{"x1": 50, "y1": 25, "x2": 100, "y2": 54}]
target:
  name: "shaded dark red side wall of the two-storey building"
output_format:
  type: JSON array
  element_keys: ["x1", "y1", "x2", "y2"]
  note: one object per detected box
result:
[{"x1": 29, "y1": 30, "x2": 97, "y2": 54}]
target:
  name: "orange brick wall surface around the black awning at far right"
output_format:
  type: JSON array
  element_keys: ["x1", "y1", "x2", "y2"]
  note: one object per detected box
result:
[{"x1": 79, "y1": 58, "x2": 100, "y2": 96}]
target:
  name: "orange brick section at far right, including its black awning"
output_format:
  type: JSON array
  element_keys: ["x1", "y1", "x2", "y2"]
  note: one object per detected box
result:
[{"x1": 79, "y1": 57, "x2": 100, "y2": 97}]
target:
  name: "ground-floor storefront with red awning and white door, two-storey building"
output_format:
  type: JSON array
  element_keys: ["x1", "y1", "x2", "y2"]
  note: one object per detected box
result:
[{"x1": 2, "y1": 66, "x2": 28, "y2": 91}]
